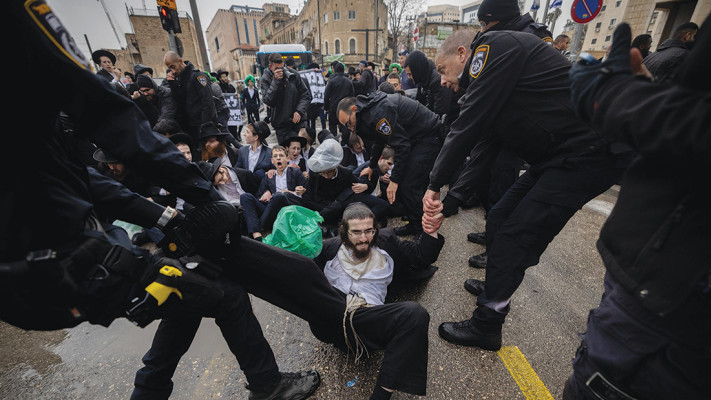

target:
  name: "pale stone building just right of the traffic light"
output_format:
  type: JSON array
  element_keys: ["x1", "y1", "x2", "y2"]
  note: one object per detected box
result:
[{"x1": 206, "y1": 5, "x2": 265, "y2": 80}]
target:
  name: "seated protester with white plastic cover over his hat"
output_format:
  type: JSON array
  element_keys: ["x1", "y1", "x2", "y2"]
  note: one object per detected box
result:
[{"x1": 302, "y1": 140, "x2": 356, "y2": 235}]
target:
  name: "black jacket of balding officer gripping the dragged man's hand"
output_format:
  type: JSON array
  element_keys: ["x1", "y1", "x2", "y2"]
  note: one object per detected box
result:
[{"x1": 428, "y1": 31, "x2": 604, "y2": 191}]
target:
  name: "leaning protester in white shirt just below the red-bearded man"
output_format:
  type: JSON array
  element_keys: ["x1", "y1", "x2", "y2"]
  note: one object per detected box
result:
[{"x1": 198, "y1": 157, "x2": 259, "y2": 205}]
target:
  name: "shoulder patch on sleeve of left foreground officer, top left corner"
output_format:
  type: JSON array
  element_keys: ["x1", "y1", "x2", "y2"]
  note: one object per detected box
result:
[{"x1": 25, "y1": 0, "x2": 91, "y2": 70}]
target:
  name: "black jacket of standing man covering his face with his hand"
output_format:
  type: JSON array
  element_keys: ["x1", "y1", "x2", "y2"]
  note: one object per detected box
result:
[{"x1": 260, "y1": 67, "x2": 311, "y2": 129}]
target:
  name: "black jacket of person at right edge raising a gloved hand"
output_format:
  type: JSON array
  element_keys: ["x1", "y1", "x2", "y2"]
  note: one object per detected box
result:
[{"x1": 593, "y1": 18, "x2": 711, "y2": 315}]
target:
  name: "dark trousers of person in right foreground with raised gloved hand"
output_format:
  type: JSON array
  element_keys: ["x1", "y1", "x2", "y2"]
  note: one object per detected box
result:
[{"x1": 563, "y1": 274, "x2": 711, "y2": 400}]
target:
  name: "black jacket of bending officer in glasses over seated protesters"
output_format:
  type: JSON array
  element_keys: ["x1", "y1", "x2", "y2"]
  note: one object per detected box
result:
[{"x1": 356, "y1": 91, "x2": 442, "y2": 183}]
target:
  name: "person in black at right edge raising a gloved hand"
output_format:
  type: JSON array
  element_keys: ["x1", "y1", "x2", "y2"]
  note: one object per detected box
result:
[{"x1": 563, "y1": 21, "x2": 711, "y2": 400}]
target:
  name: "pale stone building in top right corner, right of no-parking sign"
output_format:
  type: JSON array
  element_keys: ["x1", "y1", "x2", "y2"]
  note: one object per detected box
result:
[{"x1": 582, "y1": 0, "x2": 711, "y2": 57}]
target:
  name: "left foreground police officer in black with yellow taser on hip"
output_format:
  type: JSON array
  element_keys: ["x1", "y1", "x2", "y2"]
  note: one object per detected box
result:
[{"x1": 0, "y1": 0, "x2": 318, "y2": 399}]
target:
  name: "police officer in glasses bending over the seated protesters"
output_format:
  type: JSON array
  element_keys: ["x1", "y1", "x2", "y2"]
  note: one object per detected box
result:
[{"x1": 338, "y1": 91, "x2": 442, "y2": 235}]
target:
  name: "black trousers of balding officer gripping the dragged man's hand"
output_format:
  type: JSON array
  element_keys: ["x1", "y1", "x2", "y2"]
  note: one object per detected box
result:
[{"x1": 474, "y1": 152, "x2": 622, "y2": 324}]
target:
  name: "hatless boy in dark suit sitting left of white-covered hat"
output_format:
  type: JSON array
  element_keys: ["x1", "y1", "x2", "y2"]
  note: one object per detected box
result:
[{"x1": 240, "y1": 146, "x2": 309, "y2": 240}]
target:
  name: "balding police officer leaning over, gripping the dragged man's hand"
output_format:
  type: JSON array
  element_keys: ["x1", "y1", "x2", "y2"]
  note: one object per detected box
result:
[{"x1": 423, "y1": 24, "x2": 620, "y2": 351}]
